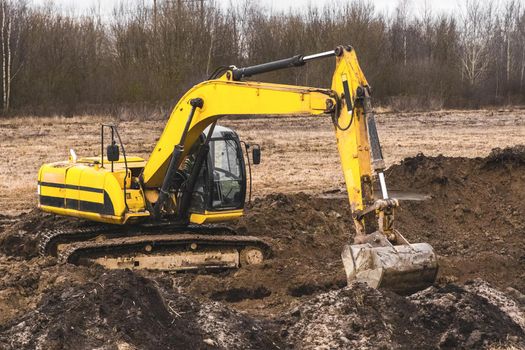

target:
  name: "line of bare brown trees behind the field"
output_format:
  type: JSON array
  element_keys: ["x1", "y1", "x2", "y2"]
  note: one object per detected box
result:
[{"x1": 0, "y1": 0, "x2": 525, "y2": 115}]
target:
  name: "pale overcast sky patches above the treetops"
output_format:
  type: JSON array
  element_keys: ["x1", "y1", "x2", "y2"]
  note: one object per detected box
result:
[{"x1": 29, "y1": 0, "x2": 462, "y2": 15}]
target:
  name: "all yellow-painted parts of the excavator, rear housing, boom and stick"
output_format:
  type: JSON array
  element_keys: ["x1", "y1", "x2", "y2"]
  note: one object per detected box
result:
[{"x1": 38, "y1": 45, "x2": 388, "y2": 238}]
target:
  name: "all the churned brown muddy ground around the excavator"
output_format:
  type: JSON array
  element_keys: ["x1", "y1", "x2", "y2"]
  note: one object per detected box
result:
[{"x1": 0, "y1": 146, "x2": 525, "y2": 349}]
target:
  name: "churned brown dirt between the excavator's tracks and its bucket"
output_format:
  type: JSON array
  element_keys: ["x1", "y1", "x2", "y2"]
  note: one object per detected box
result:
[{"x1": 175, "y1": 194, "x2": 354, "y2": 317}]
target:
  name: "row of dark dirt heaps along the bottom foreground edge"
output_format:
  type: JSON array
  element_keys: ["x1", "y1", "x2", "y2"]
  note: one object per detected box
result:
[{"x1": 0, "y1": 266, "x2": 525, "y2": 349}]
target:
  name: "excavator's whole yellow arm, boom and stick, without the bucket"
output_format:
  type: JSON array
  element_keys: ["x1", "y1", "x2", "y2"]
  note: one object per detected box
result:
[{"x1": 142, "y1": 47, "x2": 375, "y2": 234}]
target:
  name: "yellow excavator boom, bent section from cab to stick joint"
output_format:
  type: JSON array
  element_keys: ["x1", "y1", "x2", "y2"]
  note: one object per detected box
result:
[{"x1": 143, "y1": 82, "x2": 335, "y2": 187}]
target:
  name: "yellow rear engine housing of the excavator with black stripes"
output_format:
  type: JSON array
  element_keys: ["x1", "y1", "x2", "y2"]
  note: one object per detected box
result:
[{"x1": 38, "y1": 157, "x2": 149, "y2": 224}]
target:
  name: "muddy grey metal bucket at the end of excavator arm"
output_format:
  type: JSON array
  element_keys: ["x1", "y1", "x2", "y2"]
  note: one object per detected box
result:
[{"x1": 341, "y1": 234, "x2": 438, "y2": 294}]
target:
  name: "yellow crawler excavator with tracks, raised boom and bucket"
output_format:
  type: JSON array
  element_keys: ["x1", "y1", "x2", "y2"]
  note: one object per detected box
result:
[{"x1": 38, "y1": 46, "x2": 437, "y2": 292}]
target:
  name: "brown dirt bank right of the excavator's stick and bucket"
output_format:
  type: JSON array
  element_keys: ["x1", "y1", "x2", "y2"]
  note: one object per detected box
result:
[{"x1": 387, "y1": 146, "x2": 525, "y2": 292}]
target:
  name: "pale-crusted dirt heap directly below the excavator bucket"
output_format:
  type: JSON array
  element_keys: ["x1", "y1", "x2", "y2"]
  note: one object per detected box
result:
[{"x1": 283, "y1": 283, "x2": 426, "y2": 349}]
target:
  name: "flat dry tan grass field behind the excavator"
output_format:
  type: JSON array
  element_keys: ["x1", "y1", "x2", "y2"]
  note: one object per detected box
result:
[{"x1": 0, "y1": 109, "x2": 525, "y2": 214}]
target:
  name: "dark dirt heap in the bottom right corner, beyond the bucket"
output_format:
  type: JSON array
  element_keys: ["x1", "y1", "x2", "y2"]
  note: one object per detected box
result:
[{"x1": 409, "y1": 279, "x2": 525, "y2": 349}]
